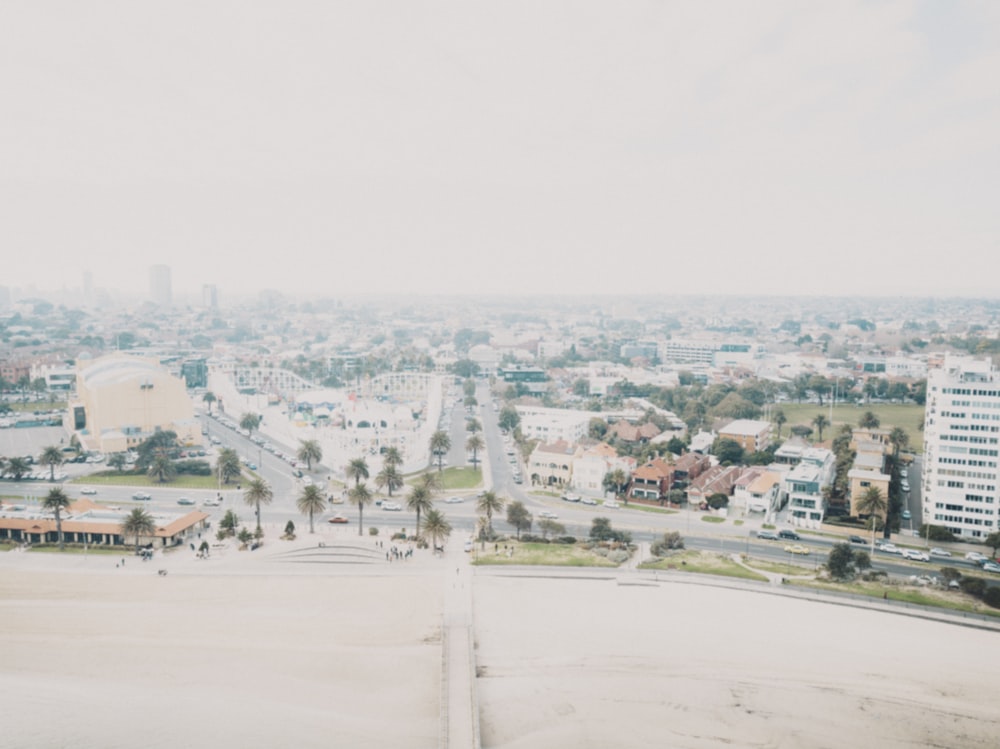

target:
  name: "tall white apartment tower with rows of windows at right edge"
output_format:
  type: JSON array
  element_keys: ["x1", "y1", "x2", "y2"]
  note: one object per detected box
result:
[{"x1": 921, "y1": 356, "x2": 1000, "y2": 539}]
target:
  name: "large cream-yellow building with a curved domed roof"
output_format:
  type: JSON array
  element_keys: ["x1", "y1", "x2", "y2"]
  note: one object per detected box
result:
[{"x1": 66, "y1": 354, "x2": 201, "y2": 453}]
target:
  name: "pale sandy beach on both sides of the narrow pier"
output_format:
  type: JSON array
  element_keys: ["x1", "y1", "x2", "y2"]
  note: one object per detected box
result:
[{"x1": 0, "y1": 536, "x2": 1000, "y2": 749}]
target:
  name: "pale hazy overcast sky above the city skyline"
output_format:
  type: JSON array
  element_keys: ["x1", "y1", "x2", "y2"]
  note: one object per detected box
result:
[{"x1": 0, "y1": 0, "x2": 1000, "y2": 295}]
